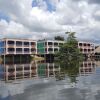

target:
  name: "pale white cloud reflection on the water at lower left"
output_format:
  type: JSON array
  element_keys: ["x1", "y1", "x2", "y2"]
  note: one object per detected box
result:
[{"x1": 0, "y1": 79, "x2": 57, "y2": 100}]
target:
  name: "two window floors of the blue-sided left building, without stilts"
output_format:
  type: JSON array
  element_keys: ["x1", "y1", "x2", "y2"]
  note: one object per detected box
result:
[{"x1": 0, "y1": 38, "x2": 37, "y2": 55}]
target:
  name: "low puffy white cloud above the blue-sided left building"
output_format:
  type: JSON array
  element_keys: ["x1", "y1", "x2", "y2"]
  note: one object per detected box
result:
[{"x1": 0, "y1": 20, "x2": 30, "y2": 38}]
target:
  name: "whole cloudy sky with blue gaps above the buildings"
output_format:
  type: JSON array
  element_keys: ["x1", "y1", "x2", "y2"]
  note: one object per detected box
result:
[{"x1": 0, "y1": 0, "x2": 100, "y2": 43}]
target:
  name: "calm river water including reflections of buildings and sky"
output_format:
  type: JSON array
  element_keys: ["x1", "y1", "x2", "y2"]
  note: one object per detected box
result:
[{"x1": 0, "y1": 61, "x2": 100, "y2": 100}]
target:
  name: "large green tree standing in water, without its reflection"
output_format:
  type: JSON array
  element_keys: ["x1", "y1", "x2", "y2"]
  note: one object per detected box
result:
[{"x1": 57, "y1": 32, "x2": 82, "y2": 65}]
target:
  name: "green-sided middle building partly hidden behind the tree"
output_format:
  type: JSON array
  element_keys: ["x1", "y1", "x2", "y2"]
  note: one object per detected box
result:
[{"x1": 37, "y1": 40, "x2": 64, "y2": 54}]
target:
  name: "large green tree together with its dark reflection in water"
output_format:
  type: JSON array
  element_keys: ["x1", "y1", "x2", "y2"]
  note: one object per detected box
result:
[{"x1": 57, "y1": 32, "x2": 83, "y2": 82}]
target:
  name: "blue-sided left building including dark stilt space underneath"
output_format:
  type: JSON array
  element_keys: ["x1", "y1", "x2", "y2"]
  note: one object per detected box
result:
[{"x1": 0, "y1": 38, "x2": 37, "y2": 63}]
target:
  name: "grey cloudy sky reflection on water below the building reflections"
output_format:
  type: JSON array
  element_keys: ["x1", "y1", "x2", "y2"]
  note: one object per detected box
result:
[{"x1": 0, "y1": 61, "x2": 100, "y2": 100}]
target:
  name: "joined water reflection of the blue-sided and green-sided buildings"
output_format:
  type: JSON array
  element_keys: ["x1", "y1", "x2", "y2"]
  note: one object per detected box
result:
[{"x1": 0, "y1": 61, "x2": 61, "y2": 81}]
